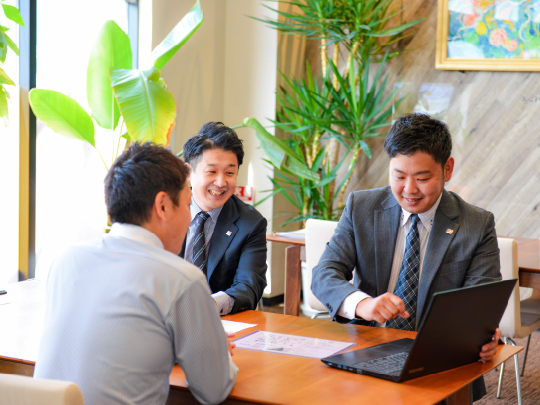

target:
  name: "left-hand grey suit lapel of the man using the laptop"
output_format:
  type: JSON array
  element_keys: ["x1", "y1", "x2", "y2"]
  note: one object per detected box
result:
[{"x1": 374, "y1": 193, "x2": 401, "y2": 296}]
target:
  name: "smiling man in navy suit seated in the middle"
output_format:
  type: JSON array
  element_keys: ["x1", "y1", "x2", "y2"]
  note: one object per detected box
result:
[{"x1": 180, "y1": 122, "x2": 267, "y2": 315}]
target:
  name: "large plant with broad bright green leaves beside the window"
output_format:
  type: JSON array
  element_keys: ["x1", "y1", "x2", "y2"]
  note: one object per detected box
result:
[{"x1": 28, "y1": 0, "x2": 203, "y2": 166}]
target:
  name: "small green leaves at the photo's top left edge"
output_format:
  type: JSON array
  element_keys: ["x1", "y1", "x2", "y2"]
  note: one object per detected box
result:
[{"x1": 0, "y1": 4, "x2": 24, "y2": 125}]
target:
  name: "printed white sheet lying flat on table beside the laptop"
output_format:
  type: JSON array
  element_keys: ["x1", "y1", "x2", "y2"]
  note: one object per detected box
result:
[{"x1": 234, "y1": 331, "x2": 356, "y2": 359}]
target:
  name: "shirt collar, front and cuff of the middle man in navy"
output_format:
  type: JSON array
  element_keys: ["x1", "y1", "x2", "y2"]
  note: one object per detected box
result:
[{"x1": 184, "y1": 198, "x2": 234, "y2": 315}]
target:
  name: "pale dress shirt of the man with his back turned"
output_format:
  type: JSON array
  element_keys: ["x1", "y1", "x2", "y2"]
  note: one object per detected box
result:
[{"x1": 34, "y1": 223, "x2": 238, "y2": 405}]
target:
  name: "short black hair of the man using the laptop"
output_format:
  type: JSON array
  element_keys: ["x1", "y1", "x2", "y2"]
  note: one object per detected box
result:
[{"x1": 384, "y1": 113, "x2": 452, "y2": 168}]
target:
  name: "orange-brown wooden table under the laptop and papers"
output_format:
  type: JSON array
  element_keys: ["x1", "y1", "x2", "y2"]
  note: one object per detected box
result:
[{"x1": 169, "y1": 311, "x2": 522, "y2": 405}]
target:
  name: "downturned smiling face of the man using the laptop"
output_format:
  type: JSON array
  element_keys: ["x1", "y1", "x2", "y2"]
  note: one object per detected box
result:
[{"x1": 390, "y1": 151, "x2": 454, "y2": 214}]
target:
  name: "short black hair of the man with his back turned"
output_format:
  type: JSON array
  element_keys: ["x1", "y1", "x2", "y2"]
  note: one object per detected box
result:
[{"x1": 105, "y1": 142, "x2": 189, "y2": 225}]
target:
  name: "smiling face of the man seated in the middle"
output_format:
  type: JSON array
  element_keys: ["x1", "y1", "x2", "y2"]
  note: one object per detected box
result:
[{"x1": 190, "y1": 149, "x2": 238, "y2": 211}]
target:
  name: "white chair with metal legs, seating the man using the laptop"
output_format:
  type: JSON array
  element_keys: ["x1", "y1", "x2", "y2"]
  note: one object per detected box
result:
[{"x1": 497, "y1": 238, "x2": 540, "y2": 405}]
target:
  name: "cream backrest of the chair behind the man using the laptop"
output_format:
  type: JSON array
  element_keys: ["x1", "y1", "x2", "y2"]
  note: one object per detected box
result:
[{"x1": 497, "y1": 238, "x2": 521, "y2": 338}]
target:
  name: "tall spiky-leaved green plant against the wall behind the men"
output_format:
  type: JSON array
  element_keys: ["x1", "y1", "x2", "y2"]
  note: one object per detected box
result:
[{"x1": 243, "y1": 0, "x2": 422, "y2": 225}]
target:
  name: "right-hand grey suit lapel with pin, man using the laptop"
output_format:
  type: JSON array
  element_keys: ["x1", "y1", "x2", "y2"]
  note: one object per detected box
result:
[{"x1": 416, "y1": 190, "x2": 459, "y2": 327}]
